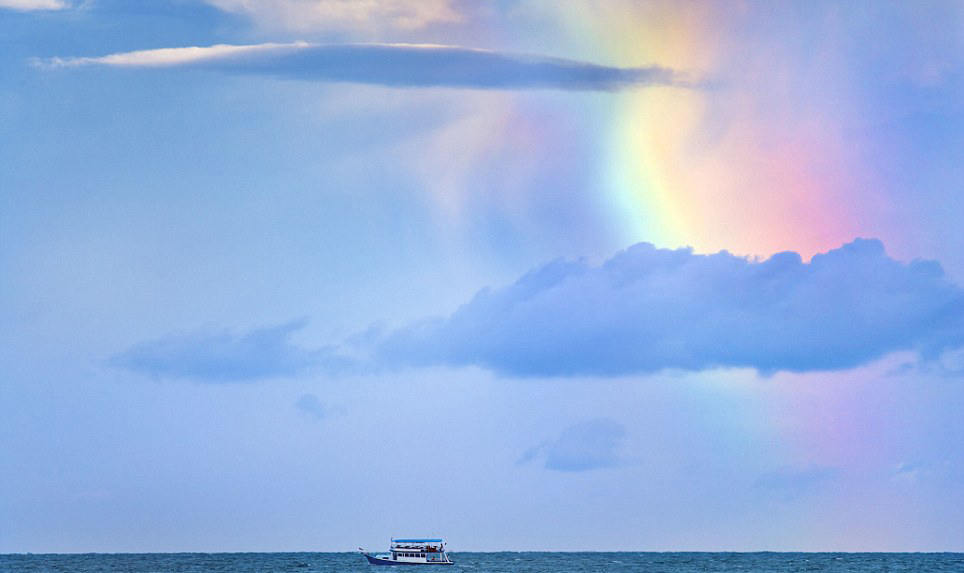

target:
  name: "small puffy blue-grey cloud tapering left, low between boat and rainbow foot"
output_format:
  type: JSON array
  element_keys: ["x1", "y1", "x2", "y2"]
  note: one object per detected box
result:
[{"x1": 518, "y1": 418, "x2": 626, "y2": 472}]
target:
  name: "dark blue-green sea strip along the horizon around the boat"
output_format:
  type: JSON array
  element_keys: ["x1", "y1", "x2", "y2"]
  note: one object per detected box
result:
[{"x1": 0, "y1": 552, "x2": 964, "y2": 573}]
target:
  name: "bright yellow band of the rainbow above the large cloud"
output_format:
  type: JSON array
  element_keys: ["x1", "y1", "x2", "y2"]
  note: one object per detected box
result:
[{"x1": 595, "y1": 3, "x2": 712, "y2": 247}]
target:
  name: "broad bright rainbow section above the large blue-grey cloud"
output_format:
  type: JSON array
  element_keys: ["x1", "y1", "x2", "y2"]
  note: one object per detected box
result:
[{"x1": 548, "y1": 3, "x2": 873, "y2": 257}]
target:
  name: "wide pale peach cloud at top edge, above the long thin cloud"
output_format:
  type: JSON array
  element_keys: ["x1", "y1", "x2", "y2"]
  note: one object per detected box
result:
[{"x1": 206, "y1": 0, "x2": 461, "y2": 32}]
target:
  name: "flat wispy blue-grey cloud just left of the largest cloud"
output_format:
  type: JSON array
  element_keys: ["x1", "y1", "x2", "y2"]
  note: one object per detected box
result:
[{"x1": 110, "y1": 321, "x2": 325, "y2": 383}]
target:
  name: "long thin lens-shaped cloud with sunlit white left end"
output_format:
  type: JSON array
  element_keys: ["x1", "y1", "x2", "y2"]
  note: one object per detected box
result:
[{"x1": 33, "y1": 42, "x2": 692, "y2": 90}]
